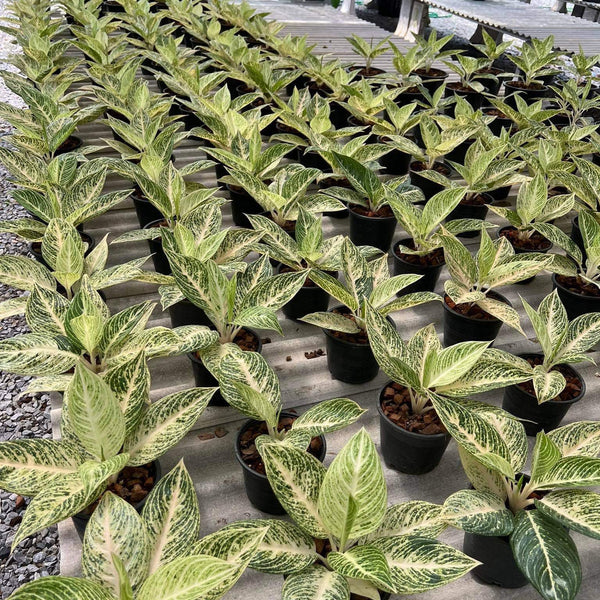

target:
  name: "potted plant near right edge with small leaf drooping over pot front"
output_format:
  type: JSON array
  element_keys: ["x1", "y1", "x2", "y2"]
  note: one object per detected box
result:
[{"x1": 502, "y1": 289, "x2": 600, "y2": 435}]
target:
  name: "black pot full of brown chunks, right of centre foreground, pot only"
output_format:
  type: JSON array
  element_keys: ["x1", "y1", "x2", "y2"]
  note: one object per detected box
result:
[{"x1": 377, "y1": 381, "x2": 451, "y2": 475}]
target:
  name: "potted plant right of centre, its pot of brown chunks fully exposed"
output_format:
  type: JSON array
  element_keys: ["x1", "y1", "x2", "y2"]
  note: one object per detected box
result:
[{"x1": 366, "y1": 307, "x2": 530, "y2": 474}]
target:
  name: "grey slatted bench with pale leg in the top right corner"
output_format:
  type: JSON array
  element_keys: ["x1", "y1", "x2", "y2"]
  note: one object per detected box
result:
[{"x1": 395, "y1": 0, "x2": 600, "y2": 55}]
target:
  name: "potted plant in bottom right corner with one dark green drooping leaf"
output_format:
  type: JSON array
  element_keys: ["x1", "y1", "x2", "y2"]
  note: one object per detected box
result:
[{"x1": 442, "y1": 414, "x2": 600, "y2": 600}]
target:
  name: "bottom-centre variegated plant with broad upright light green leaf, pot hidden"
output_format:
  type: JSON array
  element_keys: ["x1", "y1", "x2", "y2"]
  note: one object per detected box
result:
[{"x1": 251, "y1": 429, "x2": 477, "y2": 600}]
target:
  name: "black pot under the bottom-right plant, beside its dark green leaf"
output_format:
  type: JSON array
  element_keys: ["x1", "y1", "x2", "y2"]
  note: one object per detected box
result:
[{"x1": 463, "y1": 533, "x2": 528, "y2": 588}]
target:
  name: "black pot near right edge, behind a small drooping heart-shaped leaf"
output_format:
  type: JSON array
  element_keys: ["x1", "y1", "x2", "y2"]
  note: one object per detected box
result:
[{"x1": 502, "y1": 354, "x2": 585, "y2": 436}]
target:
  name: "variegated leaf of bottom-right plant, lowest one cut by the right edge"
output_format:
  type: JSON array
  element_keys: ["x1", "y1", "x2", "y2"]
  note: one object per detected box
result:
[{"x1": 535, "y1": 490, "x2": 600, "y2": 540}]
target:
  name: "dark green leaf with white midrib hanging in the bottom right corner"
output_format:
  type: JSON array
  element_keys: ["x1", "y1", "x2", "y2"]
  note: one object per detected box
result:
[{"x1": 510, "y1": 510, "x2": 581, "y2": 600}]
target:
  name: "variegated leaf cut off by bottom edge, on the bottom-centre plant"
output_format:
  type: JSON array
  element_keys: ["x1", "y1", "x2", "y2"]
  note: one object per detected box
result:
[{"x1": 281, "y1": 565, "x2": 350, "y2": 600}]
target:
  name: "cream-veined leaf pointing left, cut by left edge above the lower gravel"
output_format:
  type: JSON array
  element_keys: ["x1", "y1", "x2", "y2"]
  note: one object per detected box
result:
[{"x1": 0, "y1": 439, "x2": 84, "y2": 496}]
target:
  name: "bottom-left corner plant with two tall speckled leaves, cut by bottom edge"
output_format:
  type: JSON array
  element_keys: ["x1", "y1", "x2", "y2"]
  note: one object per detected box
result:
[{"x1": 5, "y1": 461, "x2": 270, "y2": 600}]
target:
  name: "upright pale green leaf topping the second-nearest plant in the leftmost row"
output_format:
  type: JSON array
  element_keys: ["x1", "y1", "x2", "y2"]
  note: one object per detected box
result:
[{"x1": 66, "y1": 364, "x2": 125, "y2": 460}]
